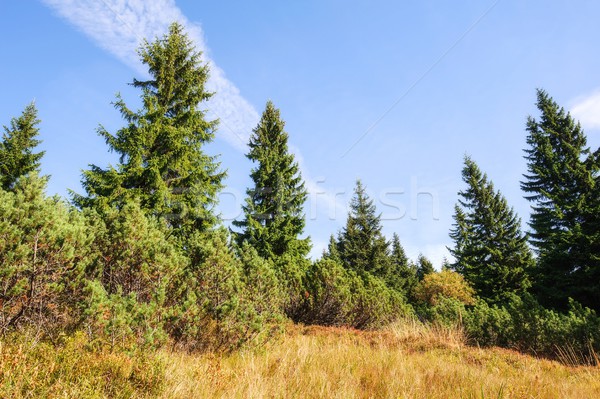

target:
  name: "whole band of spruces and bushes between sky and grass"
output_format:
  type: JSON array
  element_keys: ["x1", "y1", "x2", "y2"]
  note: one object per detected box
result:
[{"x1": 0, "y1": 24, "x2": 600, "y2": 360}]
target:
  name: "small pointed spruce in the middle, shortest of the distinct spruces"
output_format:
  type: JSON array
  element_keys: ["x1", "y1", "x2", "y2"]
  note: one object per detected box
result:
[{"x1": 339, "y1": 180, "x2": 390, "y2": 277}]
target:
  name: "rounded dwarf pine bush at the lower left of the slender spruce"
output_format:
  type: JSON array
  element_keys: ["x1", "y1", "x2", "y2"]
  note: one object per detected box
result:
[{"x1": 169, "y1": 229, "x2": 281, "y2": 351}]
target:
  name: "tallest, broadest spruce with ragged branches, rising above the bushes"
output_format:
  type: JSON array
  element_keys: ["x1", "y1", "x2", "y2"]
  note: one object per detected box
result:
[{"x1": 74, "y1": 23, "x2": 225, "y2": 234}]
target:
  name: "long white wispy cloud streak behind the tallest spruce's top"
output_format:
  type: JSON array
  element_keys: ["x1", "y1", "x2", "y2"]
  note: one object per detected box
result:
[{"x1": 42, "y1": 0, "x2": 253, "y2": 152}]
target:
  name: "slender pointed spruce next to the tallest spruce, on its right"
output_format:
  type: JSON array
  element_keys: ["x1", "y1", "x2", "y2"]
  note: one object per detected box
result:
[{"x1": 233, "y1": 101, "x2": 310, "y2": 260}]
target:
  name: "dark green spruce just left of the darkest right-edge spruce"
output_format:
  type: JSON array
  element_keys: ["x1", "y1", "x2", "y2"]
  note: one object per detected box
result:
[{"x1": 449, "y1": 157, "x2": 533, "y2": 303}]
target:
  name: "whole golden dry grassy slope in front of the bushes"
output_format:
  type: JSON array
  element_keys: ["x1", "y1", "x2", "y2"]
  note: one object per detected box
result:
[{"x1": 0, "y1": 323, "x2": 600, "y2": 398}]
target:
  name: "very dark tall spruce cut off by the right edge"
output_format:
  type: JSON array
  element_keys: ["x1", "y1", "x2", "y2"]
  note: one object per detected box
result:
[{"x1": 521, "y1": 90, "x2": 600, "y2": 310}]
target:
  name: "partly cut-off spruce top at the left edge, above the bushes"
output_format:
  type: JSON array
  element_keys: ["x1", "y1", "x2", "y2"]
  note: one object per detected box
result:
[{"x1": 0, "y1": 103, "x2": 44, "y2": 190}]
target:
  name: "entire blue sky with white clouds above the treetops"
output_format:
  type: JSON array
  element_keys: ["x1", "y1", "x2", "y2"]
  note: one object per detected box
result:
[{"x1": 0, "y1": 0, "x2": 600, "y2": 266}]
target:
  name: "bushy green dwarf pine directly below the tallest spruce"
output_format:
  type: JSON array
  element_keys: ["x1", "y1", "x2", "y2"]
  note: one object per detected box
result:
[{"x1": 84, "y1": 201, "x2": 186, "y2": 347}]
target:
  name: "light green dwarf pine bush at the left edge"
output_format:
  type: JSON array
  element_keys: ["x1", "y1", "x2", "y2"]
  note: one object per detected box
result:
[{"x1": 0, "y1": 177, "x2": 90, "y2": 336}]
